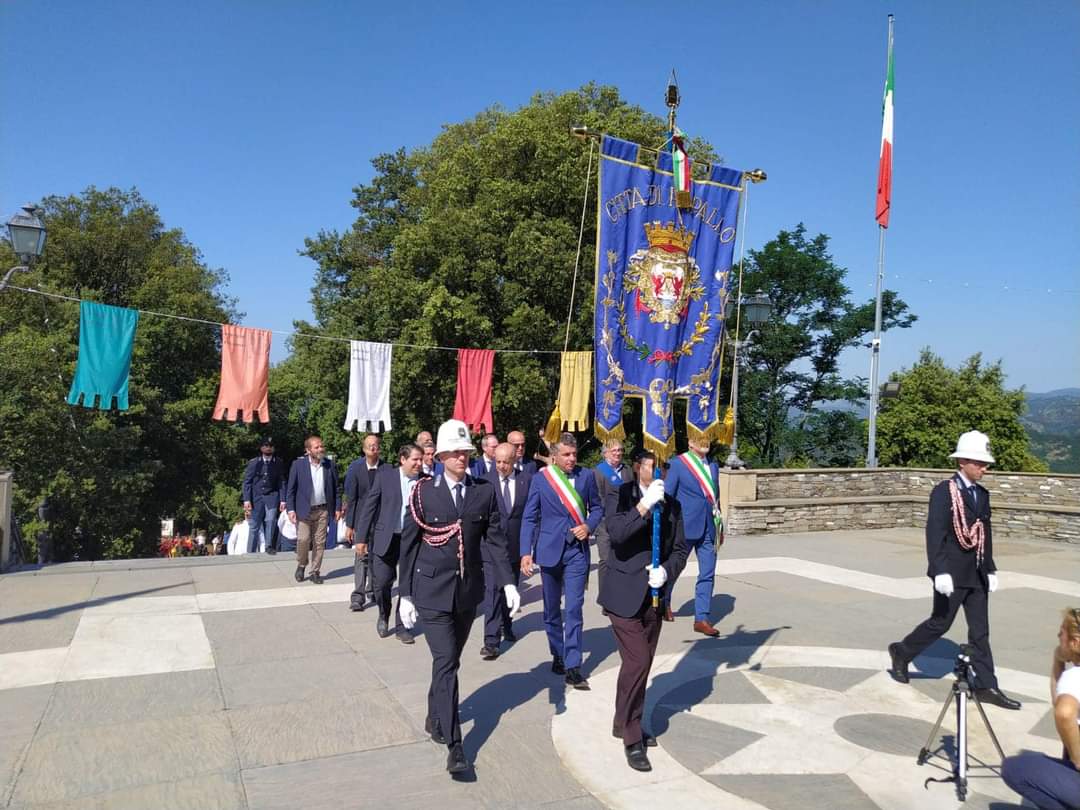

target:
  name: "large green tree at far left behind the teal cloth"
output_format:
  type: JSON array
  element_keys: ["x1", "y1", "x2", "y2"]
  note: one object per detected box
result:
[{"x1": 0, "y1": 188, "x2": 254, "y2": 559}]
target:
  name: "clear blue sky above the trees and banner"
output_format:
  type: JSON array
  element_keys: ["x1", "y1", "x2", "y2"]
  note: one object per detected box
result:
[{"x1": 0, "y1": 0, "x2": 1080, "y2": 391}]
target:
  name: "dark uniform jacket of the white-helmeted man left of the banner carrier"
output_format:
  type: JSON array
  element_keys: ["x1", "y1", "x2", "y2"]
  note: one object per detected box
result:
[{"x1": 397, "y1": 475, "x2": 514, "y2": 612}]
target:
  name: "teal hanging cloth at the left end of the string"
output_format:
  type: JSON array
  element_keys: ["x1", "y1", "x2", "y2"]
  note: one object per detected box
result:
[{"x1": 68, "y1": 301, "x2": 138, "y2": 410}]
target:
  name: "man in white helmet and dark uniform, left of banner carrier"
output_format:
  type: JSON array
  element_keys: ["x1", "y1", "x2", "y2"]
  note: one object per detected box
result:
[{"x1": 399, "y1": 419, "x2": 521, "y2": 775}]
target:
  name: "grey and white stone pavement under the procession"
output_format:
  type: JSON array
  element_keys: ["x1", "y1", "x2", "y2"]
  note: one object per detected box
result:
[{"x1": 0, "y1": 529, "x2": 1080, "y2": 810}]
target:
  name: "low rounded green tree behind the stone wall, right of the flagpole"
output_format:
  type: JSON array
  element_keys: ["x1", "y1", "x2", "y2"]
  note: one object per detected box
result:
[{"x1": 877, "y1": 349, "x2": 1047, "y2": 472}]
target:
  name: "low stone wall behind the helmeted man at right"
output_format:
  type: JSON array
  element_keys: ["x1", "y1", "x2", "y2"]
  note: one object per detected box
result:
[{"x1": 719, "y1": 468, "x2": 1080, "y2": 543}]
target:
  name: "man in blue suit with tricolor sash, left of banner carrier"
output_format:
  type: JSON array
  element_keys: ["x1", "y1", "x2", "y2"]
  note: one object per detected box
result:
[{"x1": 522, "y1": 433, "x2": 604, "y2": 689}]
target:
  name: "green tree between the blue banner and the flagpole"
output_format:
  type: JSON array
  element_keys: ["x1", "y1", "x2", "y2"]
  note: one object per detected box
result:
[{"x1": 728, "y1": 222, "x2": 916, "y2": 467}]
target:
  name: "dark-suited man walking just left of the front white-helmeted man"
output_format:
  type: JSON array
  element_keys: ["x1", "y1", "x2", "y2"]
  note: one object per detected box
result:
[{"x1": 355, "y1": 444, "x2": 423, "y2": 644}]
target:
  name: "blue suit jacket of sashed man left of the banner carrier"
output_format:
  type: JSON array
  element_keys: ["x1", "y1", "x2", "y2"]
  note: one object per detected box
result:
[{"x1": 522, "y1": 467, "x2": 604, "y2": 566}]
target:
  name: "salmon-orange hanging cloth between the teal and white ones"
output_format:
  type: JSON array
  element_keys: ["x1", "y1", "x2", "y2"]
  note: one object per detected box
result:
[{"x1": 214, "y1": 323, "x2": 270, "y2": 422}]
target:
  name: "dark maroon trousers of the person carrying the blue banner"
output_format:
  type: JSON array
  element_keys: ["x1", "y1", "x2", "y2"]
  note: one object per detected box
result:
[{"x1": 608, "y1": 598, "x2": 662, "y2": 745}]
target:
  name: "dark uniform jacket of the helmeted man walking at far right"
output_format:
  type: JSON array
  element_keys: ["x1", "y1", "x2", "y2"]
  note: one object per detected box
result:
[{"x1": 927, "y1": 475, "x2": 998, "y2": 588}]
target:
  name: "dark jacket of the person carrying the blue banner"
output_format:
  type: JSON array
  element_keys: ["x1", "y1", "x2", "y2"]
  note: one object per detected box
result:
[{"x1": 598, "y1": 481, "x2": 689, "y2": 618}]
